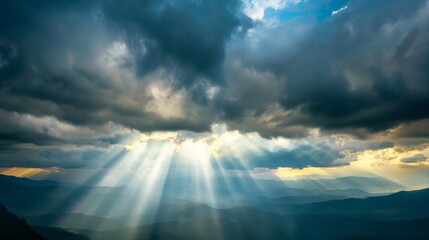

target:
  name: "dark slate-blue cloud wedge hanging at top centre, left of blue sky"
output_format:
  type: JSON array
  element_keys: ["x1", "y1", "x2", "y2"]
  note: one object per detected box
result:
[{"x1": 103, "y1": 0, "x2": 251, "y2": 85}]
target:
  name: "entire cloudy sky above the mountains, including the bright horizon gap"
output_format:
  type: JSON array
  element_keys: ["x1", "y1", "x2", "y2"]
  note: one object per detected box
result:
[{"x1": 0, "y1": 0, "x2": 429, "y2": 193}]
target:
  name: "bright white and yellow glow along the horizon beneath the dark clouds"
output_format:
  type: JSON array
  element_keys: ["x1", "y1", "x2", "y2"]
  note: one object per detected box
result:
[{"x1": 0, "y1": 124, "x2": 429, "y2": 193}]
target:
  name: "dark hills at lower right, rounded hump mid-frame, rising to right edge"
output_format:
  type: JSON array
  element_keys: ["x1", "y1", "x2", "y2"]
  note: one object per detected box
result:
[{"x1": 105, "y1": 189, "x2": 429, "y2": 240}]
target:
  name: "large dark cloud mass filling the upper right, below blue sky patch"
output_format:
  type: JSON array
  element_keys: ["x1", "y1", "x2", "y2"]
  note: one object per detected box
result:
[{"x1": 226, "y1": 1, "x2": 429, "y2": 137}]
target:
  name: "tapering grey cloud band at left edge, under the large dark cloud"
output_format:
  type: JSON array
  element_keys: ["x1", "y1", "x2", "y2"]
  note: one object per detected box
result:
[{"x1": 0, "y1": 110, "x2": 131, "y2": 152}]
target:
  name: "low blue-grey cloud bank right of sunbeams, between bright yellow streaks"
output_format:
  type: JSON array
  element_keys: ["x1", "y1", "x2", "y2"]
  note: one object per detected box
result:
[{"x1": 213, "y1": 135, "x2": 394, "y2": 170}]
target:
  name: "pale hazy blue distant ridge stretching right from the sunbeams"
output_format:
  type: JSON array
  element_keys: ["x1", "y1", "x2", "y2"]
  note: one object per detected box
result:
[{"x1": 159, "y1": 176, "x2": 372, "y2": 201}]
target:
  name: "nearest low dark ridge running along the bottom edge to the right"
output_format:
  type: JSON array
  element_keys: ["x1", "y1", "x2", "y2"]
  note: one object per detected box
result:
[{"x1": 87, "y1": 215, "x2": 429, "y2": 240}]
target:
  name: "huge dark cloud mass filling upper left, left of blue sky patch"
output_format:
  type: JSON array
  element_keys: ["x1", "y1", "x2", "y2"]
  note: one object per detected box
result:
[{"x1": 0, "y1": 0, "x2": 244, "y2": 137}]
